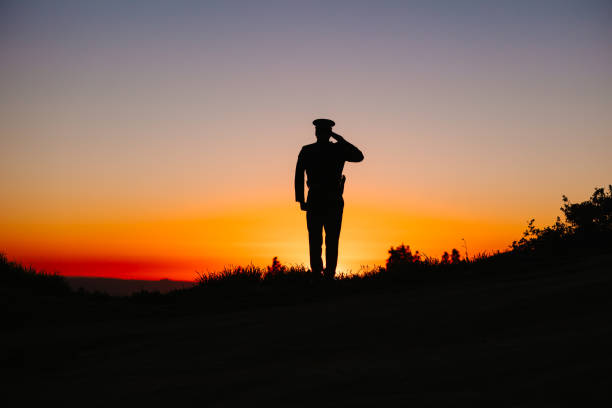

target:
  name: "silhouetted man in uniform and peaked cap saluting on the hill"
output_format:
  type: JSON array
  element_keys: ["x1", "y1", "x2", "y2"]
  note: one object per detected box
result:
[{"x1": 295, "y1": 119, "x2": 363, "y2": 278}]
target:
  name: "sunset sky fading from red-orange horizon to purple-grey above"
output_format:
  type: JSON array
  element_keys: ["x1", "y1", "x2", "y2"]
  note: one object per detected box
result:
[{"x1": 0, "y1": 0, "x2": 612, "y2": 279}]
